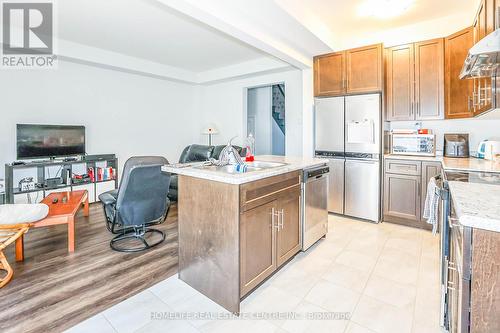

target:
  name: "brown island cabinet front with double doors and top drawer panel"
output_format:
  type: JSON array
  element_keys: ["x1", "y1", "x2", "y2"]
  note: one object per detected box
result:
[{"x1": 240, "y1": 173, "x2": 302, "y2": 297}]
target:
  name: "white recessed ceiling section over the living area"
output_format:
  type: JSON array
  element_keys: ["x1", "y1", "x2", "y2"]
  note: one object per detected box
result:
[{"x1": 57, "y1": 0, "x2": 269, "y2": 72}]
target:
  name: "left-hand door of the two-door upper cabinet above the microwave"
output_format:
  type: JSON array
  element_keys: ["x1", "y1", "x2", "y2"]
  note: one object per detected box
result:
[{"x1": 385, "y1": 44, "x2": 415, "y2": 120}]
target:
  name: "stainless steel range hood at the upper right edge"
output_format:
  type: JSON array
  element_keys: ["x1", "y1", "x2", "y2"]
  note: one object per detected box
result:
[{"x1": 460, "y1": 28, "x2": 500, "y2": 79}]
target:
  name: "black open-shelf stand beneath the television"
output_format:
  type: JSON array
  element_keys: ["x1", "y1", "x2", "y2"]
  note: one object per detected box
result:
[{"x1": 5, "y1": 154, "x2": 118, "y2": 203}]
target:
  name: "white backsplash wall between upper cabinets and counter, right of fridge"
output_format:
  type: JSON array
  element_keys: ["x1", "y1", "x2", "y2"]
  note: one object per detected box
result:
[{"x1": 391, "y1": 118, "x2": 500, "y2": 152}]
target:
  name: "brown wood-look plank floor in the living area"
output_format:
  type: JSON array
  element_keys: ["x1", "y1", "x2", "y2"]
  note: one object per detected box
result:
[{"x1": 0, "y1": 204, "x2": 178, "y2": 333}]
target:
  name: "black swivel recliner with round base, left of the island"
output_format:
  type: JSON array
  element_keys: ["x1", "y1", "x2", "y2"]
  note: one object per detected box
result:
[{"x1": 99, "y1": 156, "x2": 170, "y2": 252}]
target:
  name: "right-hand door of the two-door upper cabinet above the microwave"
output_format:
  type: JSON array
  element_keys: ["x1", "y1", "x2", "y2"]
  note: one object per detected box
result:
[{"x1": 414, "y1": 38, "x2": 444, "y2": 120}]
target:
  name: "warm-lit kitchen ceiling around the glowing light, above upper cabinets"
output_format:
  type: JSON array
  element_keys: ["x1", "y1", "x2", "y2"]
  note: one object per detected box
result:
[{"x1": 275, "y1": 0, "x2": 480, "y2": 49}]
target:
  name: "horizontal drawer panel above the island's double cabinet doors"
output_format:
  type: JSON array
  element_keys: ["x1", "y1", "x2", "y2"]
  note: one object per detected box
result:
[{"x1": 240, "y1": 171, "x2": 300, "y2": 212}]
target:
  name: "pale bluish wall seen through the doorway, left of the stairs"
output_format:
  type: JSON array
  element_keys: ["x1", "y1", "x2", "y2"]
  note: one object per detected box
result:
[{"x1": 247, "y1": 86, "x2": 272, "y2": 155}]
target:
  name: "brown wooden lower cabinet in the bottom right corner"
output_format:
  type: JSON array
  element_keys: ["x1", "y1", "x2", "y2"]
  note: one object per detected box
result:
[{"x1": 447, "y1": 221, "x2": 500, "y2": 333}]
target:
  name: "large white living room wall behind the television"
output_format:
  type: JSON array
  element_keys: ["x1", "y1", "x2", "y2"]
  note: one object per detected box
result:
[{"x1": 0, "y1": 61, "x2": 199, "y2": 178}]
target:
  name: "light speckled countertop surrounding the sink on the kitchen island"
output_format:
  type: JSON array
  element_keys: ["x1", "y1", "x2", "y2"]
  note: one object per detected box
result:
[{"x1": 162, "y1": 155, "x2": 326, "y2": 185}]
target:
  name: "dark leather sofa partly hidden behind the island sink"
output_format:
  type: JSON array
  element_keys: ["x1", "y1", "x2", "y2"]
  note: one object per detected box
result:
[{"x1": 168, "y1": 144, "x2": 245, "y2": 201}]
